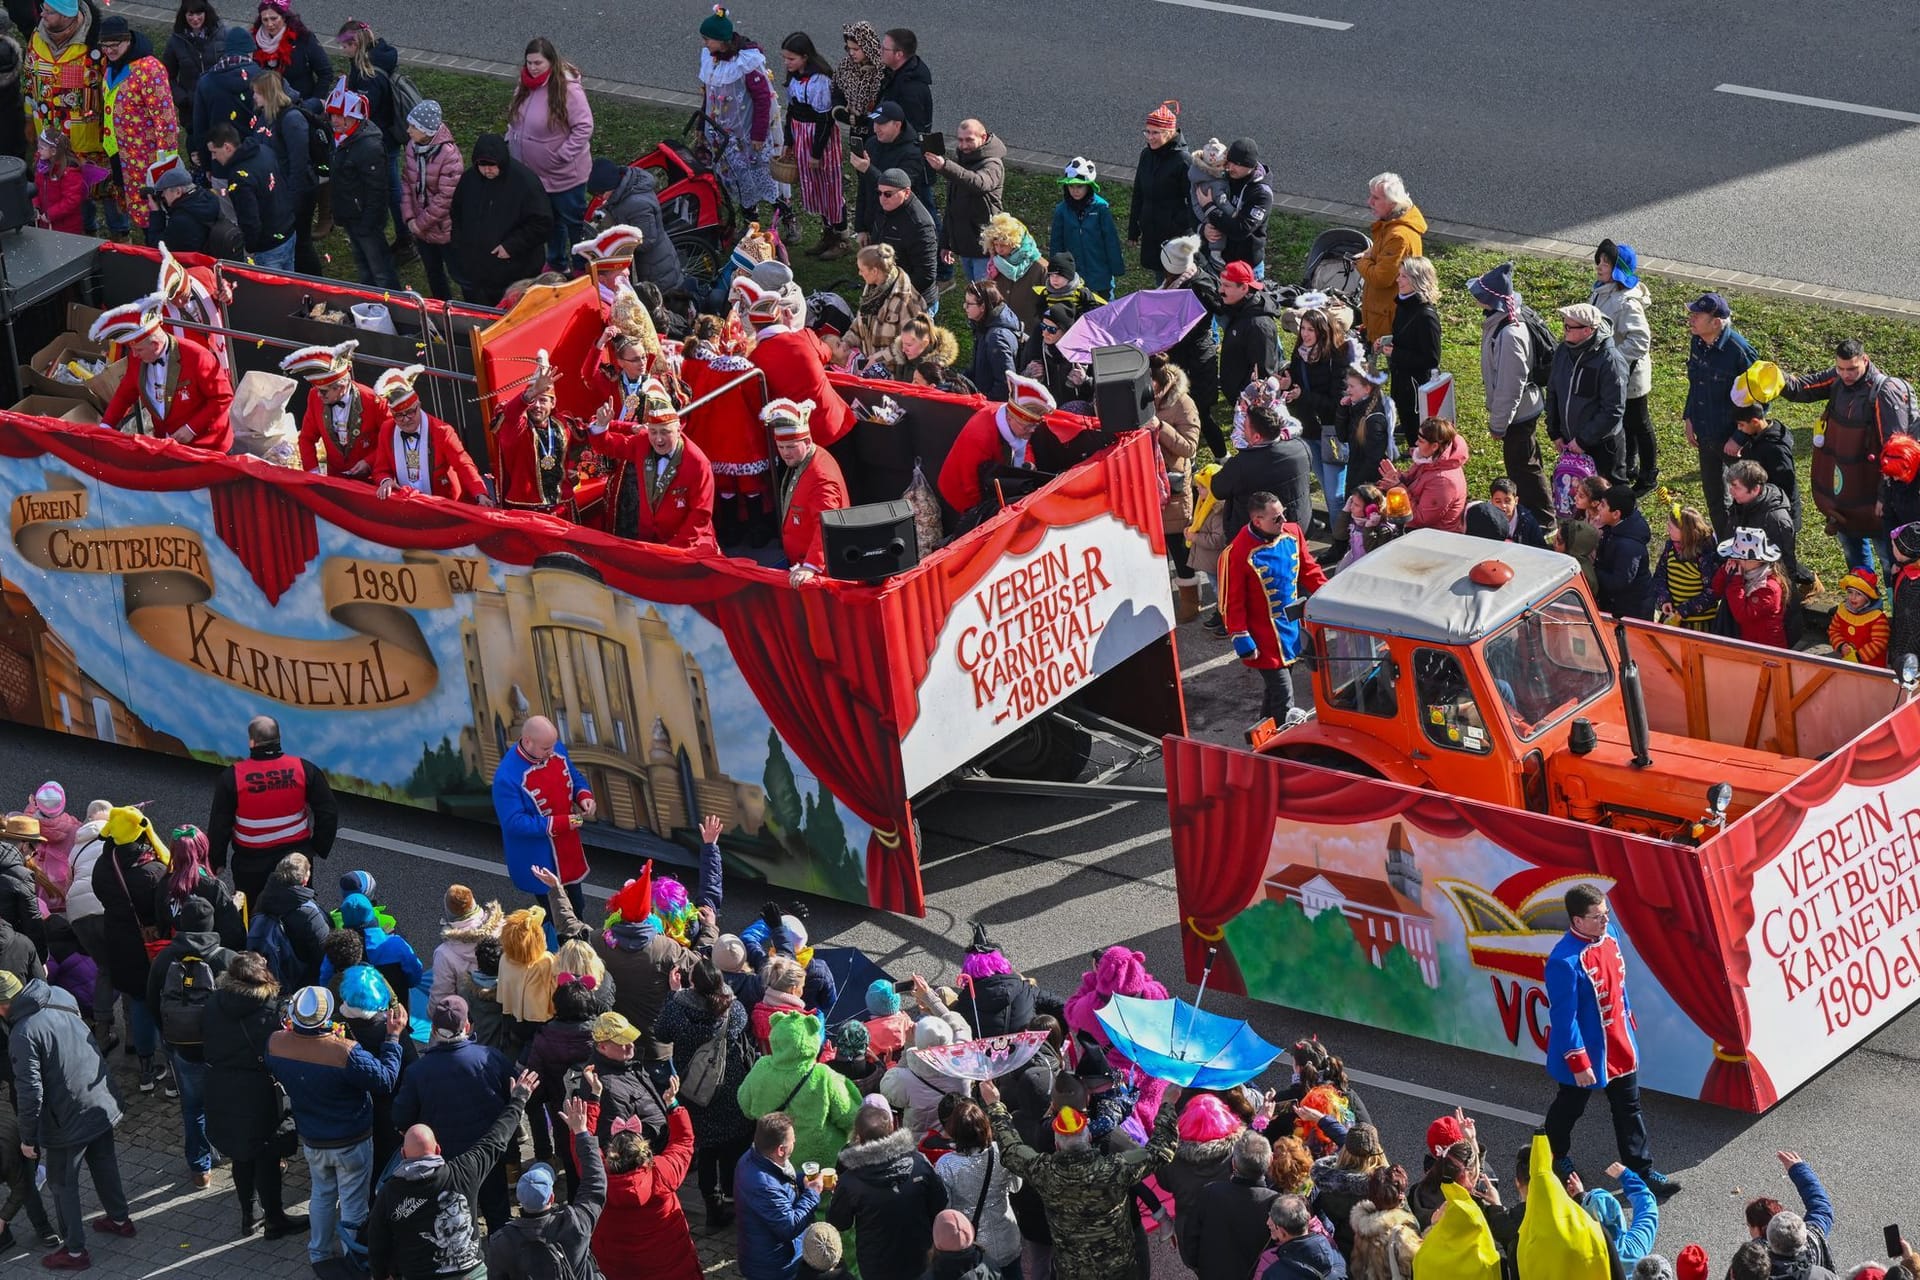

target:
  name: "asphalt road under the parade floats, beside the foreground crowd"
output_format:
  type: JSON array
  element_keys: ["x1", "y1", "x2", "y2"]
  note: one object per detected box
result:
[{"x1": 11, "y1": 610, "x2": 1920, "y2": 1268}]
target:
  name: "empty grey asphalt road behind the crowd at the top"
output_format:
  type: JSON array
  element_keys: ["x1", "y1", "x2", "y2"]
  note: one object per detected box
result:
[{"x1": 278, "y1": 0, "x2": 1920, "y2": 297}]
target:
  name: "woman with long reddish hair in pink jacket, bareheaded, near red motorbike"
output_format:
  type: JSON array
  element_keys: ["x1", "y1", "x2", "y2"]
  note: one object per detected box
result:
[{"x1": 507, "y1": 36, "x2": 593, "y2": 271}]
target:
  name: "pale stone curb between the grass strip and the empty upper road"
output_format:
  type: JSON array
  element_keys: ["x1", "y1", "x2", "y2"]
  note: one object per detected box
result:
[{"x1": 113, "y1": 0, "x2": 1920, "y2": 320}]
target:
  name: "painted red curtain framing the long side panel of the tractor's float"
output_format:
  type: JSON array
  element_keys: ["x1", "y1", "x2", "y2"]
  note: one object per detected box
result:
[{"x1": 1165, "y1": 736, "x2": 1781, "y2": 1111}]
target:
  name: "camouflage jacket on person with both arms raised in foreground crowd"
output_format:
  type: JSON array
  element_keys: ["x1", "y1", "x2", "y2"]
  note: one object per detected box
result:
[{"x1": 987, "y1": 1103, "x2": 1179, "y2": 1280}]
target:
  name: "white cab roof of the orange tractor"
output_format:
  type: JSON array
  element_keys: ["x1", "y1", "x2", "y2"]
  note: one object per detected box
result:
[{"x1": 1306, "y1": 530, "x2": 1580, "y2": 645}]
